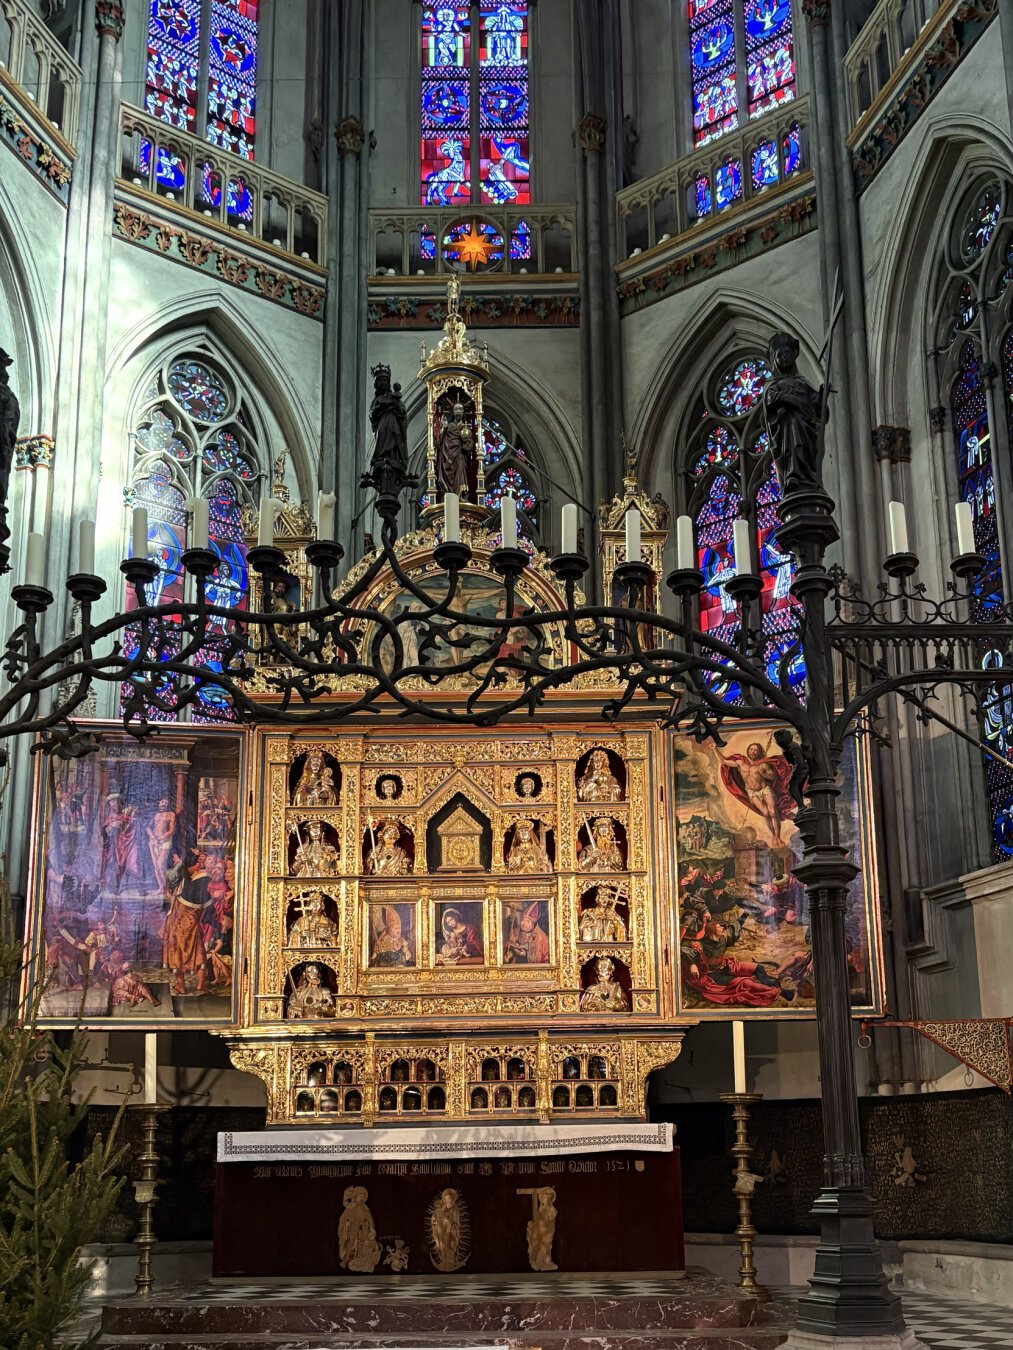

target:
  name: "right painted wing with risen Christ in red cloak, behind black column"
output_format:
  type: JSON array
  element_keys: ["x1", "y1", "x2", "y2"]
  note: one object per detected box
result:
[{"x1": 674, "y1": 725, "x2": 881, "y2": 1017}]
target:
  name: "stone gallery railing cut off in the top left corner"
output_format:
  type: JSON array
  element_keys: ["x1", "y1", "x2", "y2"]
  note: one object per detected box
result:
[{"x1": 0, "y1": 0, "x2": 81, "y2": 147}]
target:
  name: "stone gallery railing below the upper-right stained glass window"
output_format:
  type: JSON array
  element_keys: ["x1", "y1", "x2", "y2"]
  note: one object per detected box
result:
[{"x1": 616, "y1": 99, "x2": 809, "y2": 258}]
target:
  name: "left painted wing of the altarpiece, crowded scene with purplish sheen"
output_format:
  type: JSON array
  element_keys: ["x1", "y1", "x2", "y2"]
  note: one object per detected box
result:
[{"x1": 32, "y1": 728, "x2": 242, "y2": 1025}]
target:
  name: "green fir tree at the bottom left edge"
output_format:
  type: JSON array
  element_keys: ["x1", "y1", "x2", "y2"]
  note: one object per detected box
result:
[{"x1": 0, "y1": 872, "x2": 123, "y2": 1350}]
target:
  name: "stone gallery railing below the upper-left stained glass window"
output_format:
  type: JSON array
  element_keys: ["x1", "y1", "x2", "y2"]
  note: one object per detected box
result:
[{"x1": 120, "y1": 104, "x2": 327, "y2": 263}]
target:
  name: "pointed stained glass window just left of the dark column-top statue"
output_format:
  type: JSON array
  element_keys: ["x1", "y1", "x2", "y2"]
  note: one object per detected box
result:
[{"x1": 687, "y1": 355, "x2": 805, "y2": 697}]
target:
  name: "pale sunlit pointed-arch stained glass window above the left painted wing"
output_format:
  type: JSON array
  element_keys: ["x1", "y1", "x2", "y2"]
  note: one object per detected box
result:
[{"x1": 123, "y1": 354, "x2": 259, "y2": 722}]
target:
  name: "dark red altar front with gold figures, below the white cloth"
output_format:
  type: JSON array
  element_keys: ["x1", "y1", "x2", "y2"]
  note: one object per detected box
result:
[{"x1": 213, "y1": 1149, "x2": 685, "y2": 1278}]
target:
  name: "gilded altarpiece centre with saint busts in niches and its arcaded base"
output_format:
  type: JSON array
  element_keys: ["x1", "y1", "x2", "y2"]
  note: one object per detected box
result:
[{"x1": 232, "y1": 718, "x2": 682, "y2": 1123}]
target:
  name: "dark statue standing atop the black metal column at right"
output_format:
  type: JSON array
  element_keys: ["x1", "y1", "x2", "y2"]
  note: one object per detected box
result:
[{"x1": 763, "y1": 333, "x2": 827, "y2": 497}]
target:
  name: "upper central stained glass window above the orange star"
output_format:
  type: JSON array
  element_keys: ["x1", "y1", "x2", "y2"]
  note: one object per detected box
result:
[{"x1": 420, "y1": 0, "x2": 531, "y2": 207}]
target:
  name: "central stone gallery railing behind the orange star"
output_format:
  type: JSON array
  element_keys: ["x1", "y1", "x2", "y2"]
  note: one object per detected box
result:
[{"x1": 367, "y1": 207, "x2": 577, "y2": 277}]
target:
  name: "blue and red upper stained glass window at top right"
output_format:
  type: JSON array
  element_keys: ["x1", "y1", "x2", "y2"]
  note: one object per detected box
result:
[{"x1": 687, "y1": 0, "x2": 796, "y2": 148}]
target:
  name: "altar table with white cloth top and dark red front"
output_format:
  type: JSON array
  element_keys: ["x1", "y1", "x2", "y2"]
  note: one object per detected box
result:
[{"x1": 213, "y1": 1125, "x2": 685, "y2": 1278}]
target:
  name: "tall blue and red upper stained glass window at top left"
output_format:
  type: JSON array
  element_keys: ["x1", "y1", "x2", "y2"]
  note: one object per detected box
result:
[{"x1": 142, "y1": 0, "x2": 258, "y2": 157}]
